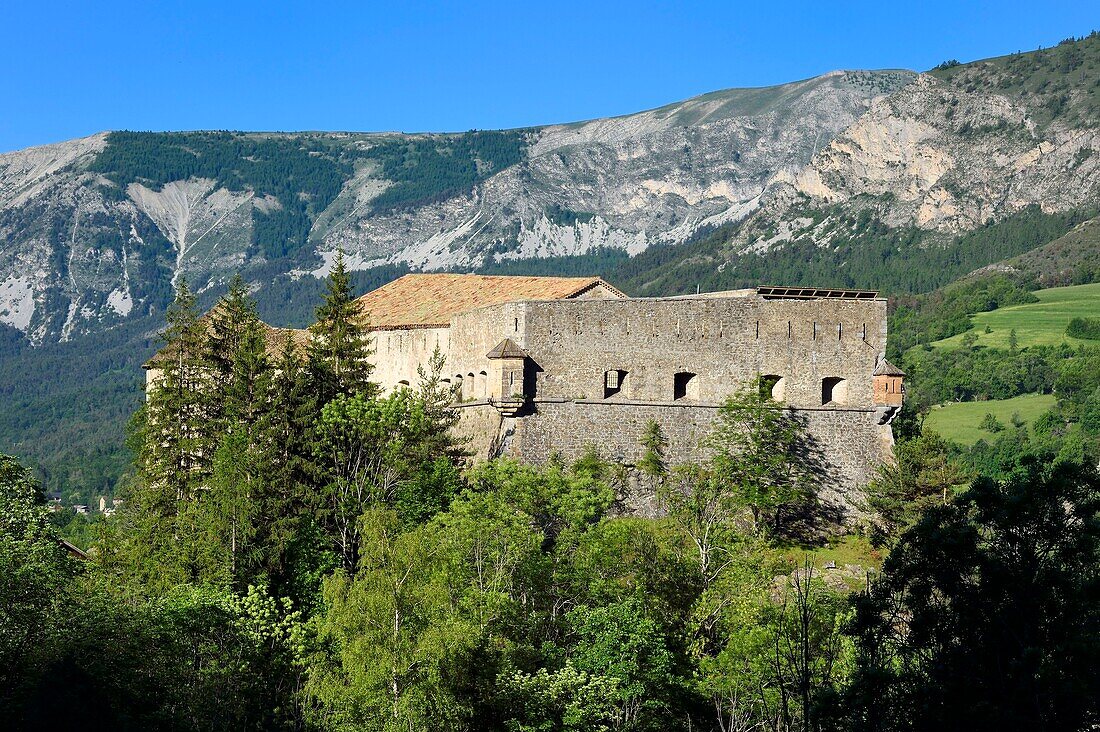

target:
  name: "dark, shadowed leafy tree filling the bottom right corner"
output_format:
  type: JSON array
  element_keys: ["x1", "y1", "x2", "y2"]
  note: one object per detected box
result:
[{"x1": 848, "y1": 459, "x2": 1100, "y2": 732}]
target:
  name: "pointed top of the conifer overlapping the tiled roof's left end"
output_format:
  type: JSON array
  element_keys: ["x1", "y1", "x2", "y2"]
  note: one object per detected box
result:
[{"x1": 308, "y1": 252, "x2": 378, "y2": 406}]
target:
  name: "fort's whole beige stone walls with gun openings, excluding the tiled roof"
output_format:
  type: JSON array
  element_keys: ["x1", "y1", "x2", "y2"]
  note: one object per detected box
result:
[{"x1": 375, "y1": 291, "x2": 893, "y2": 514}]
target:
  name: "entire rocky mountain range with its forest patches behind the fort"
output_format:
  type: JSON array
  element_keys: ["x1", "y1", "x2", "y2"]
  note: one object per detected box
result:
[{"x1": 0, "y1": 37, "x2": 1100, "y2": 343}]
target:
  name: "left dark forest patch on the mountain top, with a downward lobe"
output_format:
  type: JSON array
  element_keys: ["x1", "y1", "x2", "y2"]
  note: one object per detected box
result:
[{"x1": 90, "y1": 132, "x2": 352, "y2": 259}]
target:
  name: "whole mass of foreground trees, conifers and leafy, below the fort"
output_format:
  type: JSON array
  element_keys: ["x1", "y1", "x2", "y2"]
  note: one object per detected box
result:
[{"x1": 0, "y1": 260, "x2": 1100, "y2": 732}]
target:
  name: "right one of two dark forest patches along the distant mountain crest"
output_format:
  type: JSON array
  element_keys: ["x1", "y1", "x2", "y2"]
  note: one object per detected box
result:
[{"x1": 364, "y1": 130, "x2": 527, "y2": 212}]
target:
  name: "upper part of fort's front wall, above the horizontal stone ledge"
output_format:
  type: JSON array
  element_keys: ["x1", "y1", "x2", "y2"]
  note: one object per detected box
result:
[{"x1": 510, "y1": 296, "x2": 886, "y2": 407}]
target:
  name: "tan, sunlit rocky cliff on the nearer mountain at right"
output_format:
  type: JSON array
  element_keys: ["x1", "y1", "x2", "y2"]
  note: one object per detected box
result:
[{"x1": 738, "y1": 75, "x2": 1100, "y2": 249}]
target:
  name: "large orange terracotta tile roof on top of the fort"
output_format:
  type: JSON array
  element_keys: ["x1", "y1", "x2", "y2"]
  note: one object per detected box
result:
[{"x1": 358, "y1": 274, "x2": 626, "y2": 330}]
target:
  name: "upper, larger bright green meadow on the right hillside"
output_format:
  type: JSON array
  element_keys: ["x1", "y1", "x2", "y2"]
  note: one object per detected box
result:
[{"x1": 933, "y1": 283, "x2": 1100, "y2": 348}]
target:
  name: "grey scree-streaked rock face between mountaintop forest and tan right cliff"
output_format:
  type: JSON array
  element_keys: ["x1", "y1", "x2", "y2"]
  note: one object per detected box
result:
[{"x1": 318, "y1": 72, "x2": 913, "y2": 269}]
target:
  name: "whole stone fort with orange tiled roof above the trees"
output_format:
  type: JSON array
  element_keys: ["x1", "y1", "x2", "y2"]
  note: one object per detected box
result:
[{"x1": 147, "y1": 274, "x2": 904, "y2": 511}]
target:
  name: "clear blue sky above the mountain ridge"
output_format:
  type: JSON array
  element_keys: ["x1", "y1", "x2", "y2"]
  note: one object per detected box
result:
[{"x1": 0, "y1": 0, "x2": 1100, "y2": 151}]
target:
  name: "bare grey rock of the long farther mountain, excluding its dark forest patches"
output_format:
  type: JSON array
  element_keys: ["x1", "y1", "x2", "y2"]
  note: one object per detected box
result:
[{"x1": 0, "y1": 72, "x2": 914, "y2": 342}]
